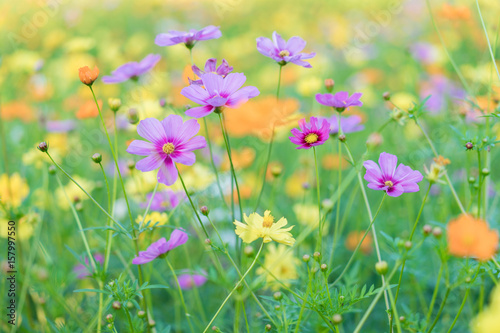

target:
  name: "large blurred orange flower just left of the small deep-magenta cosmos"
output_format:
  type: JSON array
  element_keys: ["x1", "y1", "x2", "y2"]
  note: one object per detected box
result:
[{"x1": 225, "y1": 96, "x2": 299, "y2": 140}]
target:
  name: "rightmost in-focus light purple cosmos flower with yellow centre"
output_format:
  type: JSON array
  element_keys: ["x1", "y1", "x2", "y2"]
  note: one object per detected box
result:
[{"x1": 363, "y1": 153, "x2": 424, "y2": 197}]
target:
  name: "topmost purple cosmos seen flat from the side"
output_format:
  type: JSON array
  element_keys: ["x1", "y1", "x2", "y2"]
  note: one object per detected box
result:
[{"x1": 155, "y1": 25, "x2": 222, "y2": 49}]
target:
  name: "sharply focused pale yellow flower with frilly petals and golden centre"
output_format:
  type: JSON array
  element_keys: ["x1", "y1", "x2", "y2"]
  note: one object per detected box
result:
[{"x1": 234, "y1": 210, "x2": 295, "y2": 246}]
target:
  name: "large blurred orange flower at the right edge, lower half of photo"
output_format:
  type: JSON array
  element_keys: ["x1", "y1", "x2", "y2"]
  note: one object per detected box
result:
[{"x1": 447, "y1": 214, "x2": 498, "y2": 261}]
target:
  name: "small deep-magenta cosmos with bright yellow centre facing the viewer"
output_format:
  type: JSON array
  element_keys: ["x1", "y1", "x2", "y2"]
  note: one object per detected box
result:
[{"x1": 289, "y1": 117, "x2": 330, "y2": 149}]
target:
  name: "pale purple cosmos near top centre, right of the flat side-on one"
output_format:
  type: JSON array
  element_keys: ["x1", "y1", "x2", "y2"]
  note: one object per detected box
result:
[{"x1": 257, "y1": 31, "x2": 316, "y2": 68}]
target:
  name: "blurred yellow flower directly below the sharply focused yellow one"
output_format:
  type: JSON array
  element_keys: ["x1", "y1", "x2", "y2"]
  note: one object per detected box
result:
[{"x1": 256, "y1": 244, "x2": 300, "y2": 290}]
